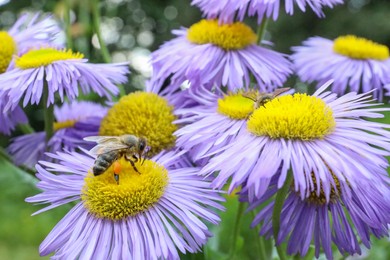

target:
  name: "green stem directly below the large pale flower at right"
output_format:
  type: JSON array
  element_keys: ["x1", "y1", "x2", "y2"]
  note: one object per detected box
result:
[{"x1": 272, "y1": 169, "x2": 293, "y2": 260}]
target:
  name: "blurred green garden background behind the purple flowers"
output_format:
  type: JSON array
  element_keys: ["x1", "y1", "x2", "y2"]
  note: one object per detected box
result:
[{"x1": 0, "y1": 0, "x2": 390, "y2": 260}]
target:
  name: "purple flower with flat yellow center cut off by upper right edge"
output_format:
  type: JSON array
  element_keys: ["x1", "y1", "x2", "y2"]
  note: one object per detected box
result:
[{"x1": 291, "y1": 35, "x2": 390, "y2": 100}]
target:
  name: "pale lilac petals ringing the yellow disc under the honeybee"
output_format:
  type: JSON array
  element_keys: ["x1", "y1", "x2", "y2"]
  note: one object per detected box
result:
[{"x1": 27, "y1": 149, "x2": 223, "y2": 259}]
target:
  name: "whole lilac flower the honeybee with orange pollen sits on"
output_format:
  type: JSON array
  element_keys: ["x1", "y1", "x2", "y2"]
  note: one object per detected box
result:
[{"x1": 27, "y1": 149, "x2": 223, "y2": 259}]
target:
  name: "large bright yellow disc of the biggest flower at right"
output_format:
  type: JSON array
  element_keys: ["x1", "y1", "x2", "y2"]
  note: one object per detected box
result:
[{"x1": 247, "y1": 93, "x2": 336, "y2": 140}]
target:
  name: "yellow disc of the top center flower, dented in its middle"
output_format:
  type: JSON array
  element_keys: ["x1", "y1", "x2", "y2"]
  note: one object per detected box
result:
[{"x1": 187, "y1": 20, "x2": 257, "y2": 50}]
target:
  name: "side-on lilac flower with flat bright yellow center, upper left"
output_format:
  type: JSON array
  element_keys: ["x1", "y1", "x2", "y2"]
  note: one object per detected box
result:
[{"x1": 0, "y1": 48, "x2": 129, "y2": 110}]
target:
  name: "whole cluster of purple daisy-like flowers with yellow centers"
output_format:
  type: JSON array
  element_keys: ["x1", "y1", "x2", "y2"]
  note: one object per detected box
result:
[{"x1": 0, "y1": 0, "x2": 390, "y2": 259}]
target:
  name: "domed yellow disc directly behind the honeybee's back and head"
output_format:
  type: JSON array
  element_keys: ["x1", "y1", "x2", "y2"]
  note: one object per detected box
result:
[{"x1": 99, "y1": 92, "x2": 177, "y2": 156}]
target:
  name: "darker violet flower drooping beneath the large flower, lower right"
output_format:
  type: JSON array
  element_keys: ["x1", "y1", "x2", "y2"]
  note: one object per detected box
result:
[{"x1": 242, "y1": 172, "x2": 390, "y2": 259}]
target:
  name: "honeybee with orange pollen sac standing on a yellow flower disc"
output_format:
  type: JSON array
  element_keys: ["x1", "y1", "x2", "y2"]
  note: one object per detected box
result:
[{"x1": 84, "y1": 135, "x2": 146, "y2": 184}]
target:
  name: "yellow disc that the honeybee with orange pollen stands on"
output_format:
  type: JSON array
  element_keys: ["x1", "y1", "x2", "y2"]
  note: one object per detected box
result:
[{"x1": 81, "y1": 157, "x2": 168, "y2": 220}]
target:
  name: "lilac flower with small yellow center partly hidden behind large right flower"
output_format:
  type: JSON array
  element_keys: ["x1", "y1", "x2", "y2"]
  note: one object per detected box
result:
[{"x1": 175, "y1": 89, "x2": 255, "y2": 163}]
